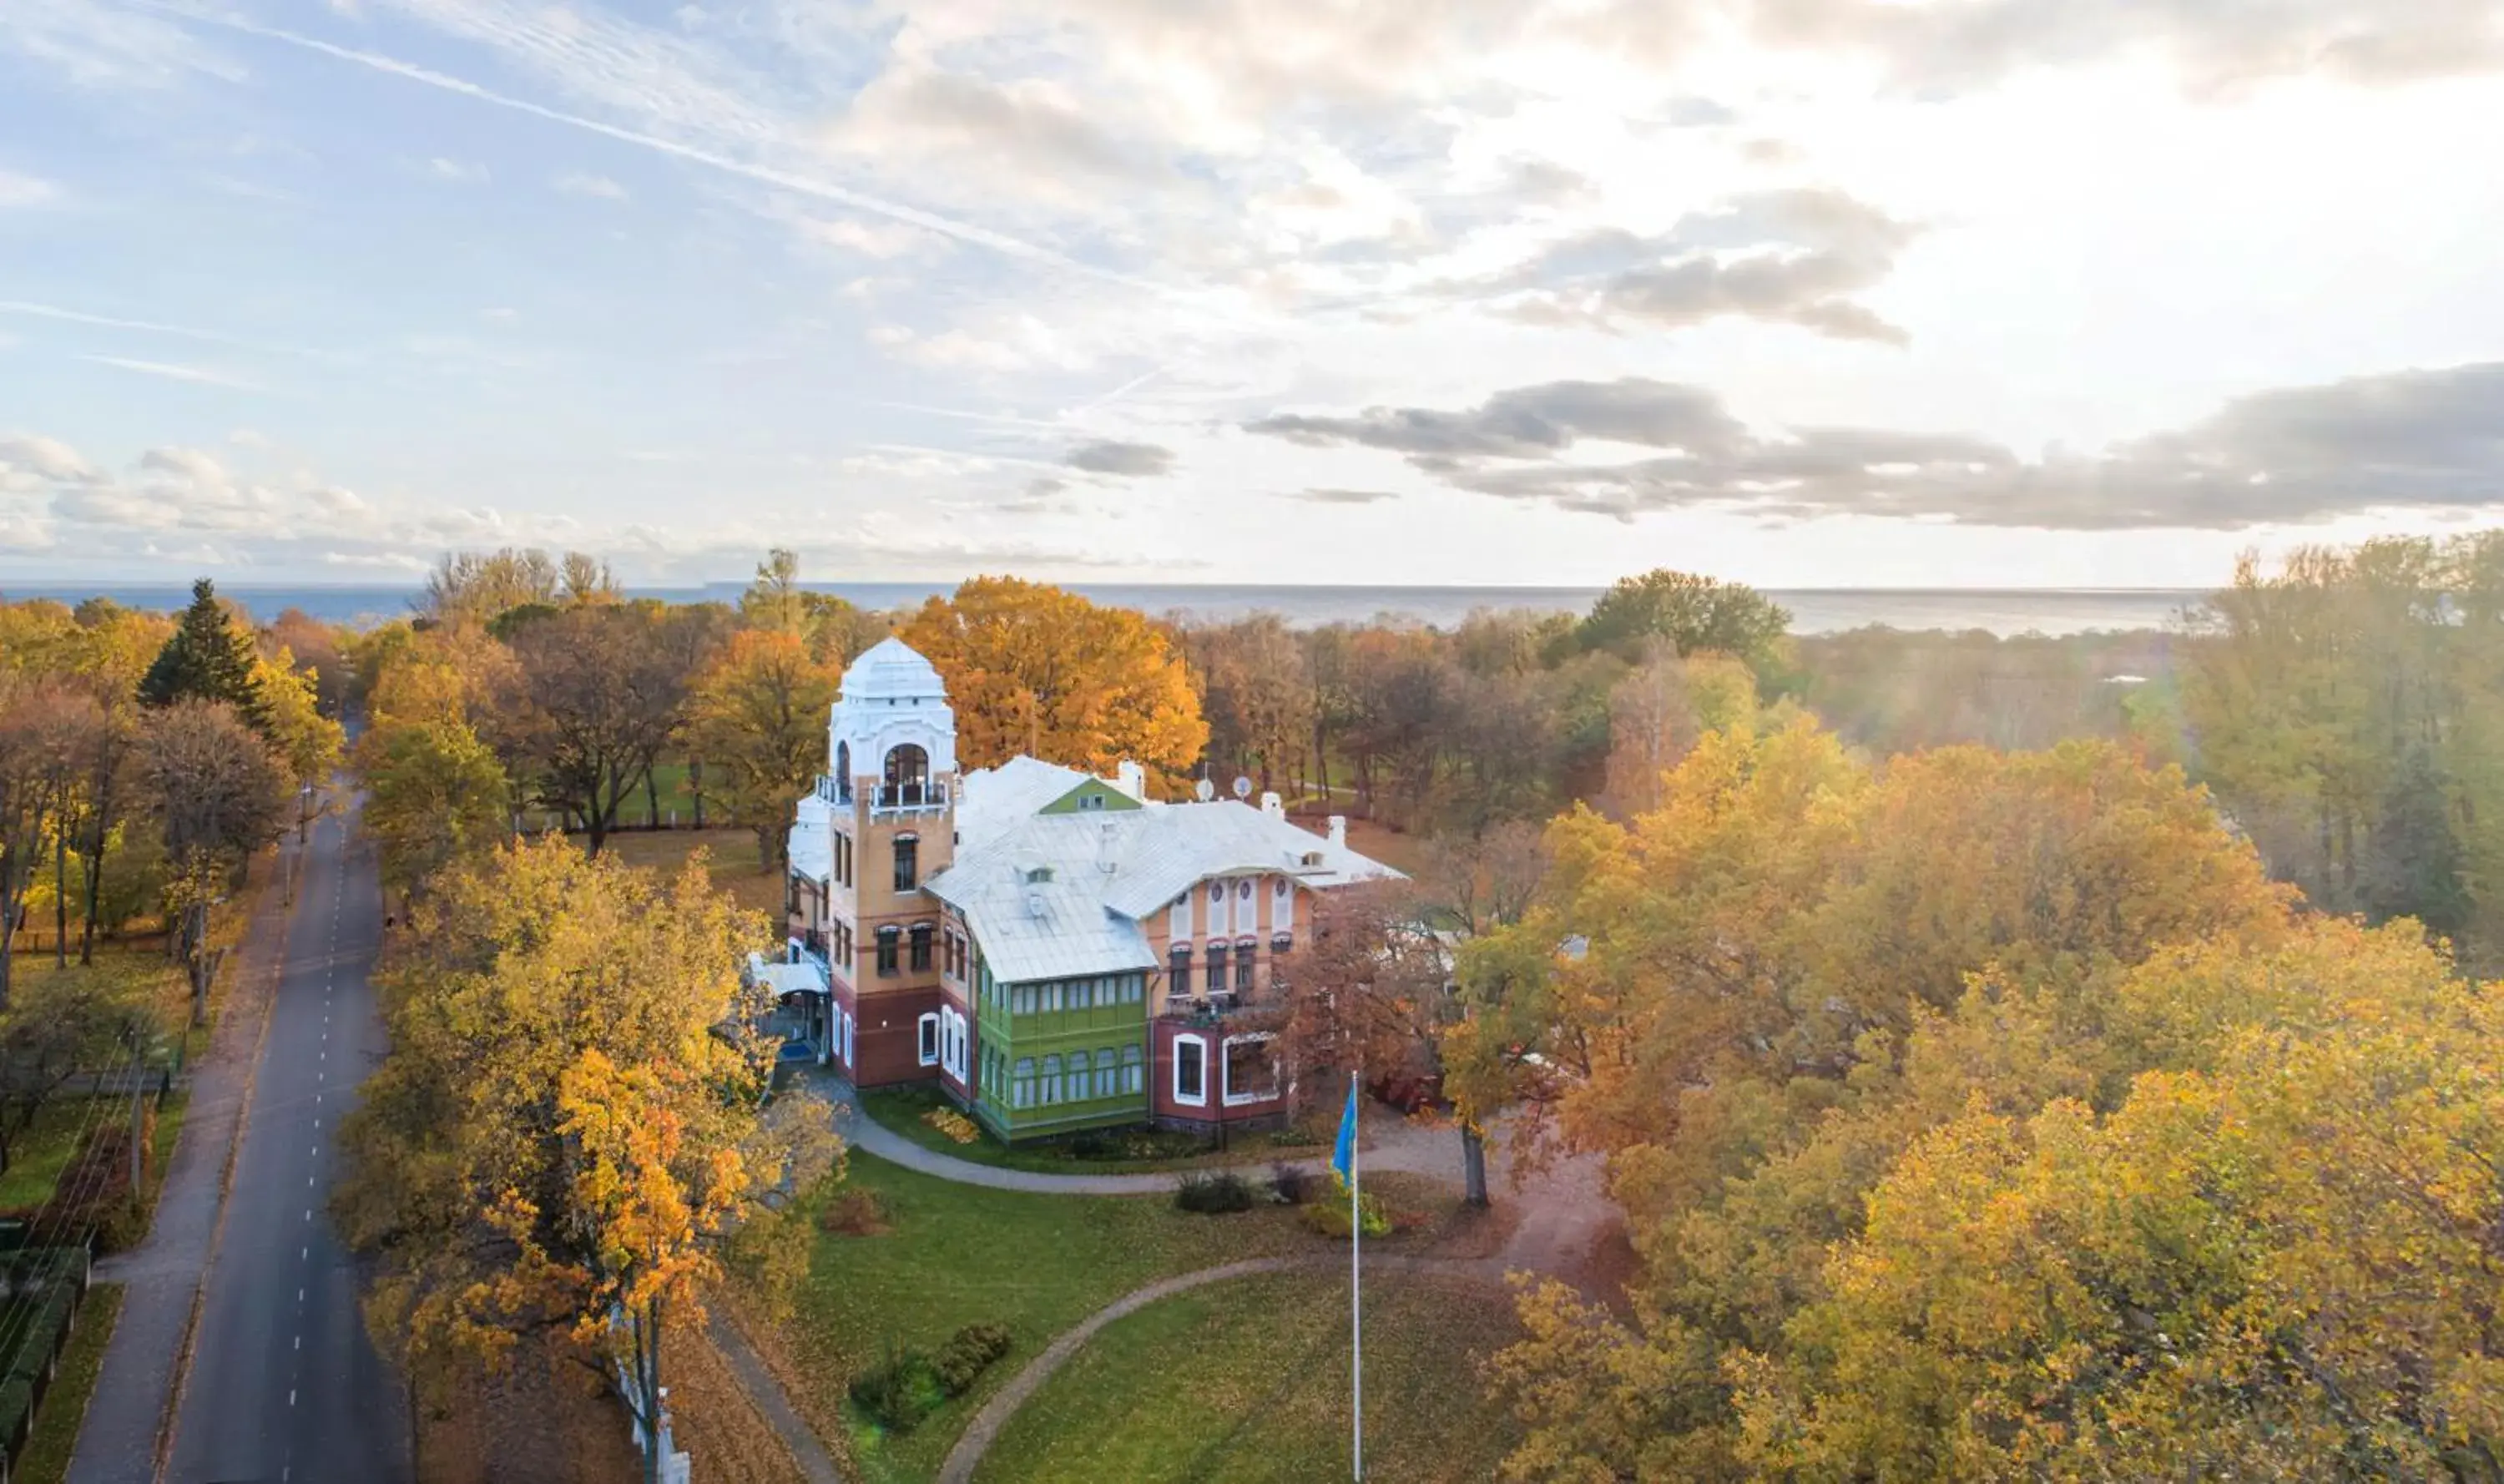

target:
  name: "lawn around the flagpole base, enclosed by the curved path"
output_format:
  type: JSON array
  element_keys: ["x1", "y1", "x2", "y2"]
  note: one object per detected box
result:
[{"x1": 974, "y1": 1271, "x2": 1517, "y2": 1484}]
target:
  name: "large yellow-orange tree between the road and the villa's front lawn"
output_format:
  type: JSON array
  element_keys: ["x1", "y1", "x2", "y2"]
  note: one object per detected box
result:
[{"x1": 336, "y1": 838, "x2": 836, "y2": 1471}]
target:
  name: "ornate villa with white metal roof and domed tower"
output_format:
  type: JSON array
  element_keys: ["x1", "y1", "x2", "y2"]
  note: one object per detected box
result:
[{"x1": 761, "y1": 639, "x2": 1397, "y2": 1138}]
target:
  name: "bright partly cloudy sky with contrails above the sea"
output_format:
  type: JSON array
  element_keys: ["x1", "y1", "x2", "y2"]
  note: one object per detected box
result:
[{"x1": 0, "y1": 0, "x2": 2504, "y2": 588}]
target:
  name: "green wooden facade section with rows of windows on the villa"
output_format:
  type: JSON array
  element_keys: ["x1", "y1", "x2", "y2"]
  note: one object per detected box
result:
[{"x1": 972, "y1": 953, "x2": 1149, "y2": 1141}]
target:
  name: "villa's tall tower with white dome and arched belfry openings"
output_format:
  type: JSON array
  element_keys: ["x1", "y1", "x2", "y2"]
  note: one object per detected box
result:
[{"x1": 821, "y1": 639, "x2": 957, "y2": 1086}]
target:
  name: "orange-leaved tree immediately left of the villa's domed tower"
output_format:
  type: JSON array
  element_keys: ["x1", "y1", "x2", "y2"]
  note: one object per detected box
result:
[{"x1": 686, "y1": 628, "x2": 841, "y2": 868}]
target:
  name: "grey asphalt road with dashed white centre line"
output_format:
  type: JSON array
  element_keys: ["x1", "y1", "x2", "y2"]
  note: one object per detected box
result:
[{"x1": 168, "y1": 818, "x2": 408, "y2": 1484}]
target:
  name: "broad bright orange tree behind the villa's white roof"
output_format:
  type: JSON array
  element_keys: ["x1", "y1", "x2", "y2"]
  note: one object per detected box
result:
[{"x1": 901, "y1": 578, "x2": 1209, "y2": 788}]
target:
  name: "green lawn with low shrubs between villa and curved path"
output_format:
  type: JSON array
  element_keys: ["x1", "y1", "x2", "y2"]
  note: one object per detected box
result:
[{"x1": 784, "y1": 1153, "x2": 1335, "y2": 1484}]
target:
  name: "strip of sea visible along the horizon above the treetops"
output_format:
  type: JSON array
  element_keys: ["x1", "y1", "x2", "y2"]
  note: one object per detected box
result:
[{"x1": 0, "y1": 581, "x2": 2209, "y2": 639}]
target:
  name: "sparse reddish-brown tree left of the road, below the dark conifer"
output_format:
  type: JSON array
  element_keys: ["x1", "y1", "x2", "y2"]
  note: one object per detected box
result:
[{"x1": 140, "y1": 701, "x2": 288, "y2": 1023}]
